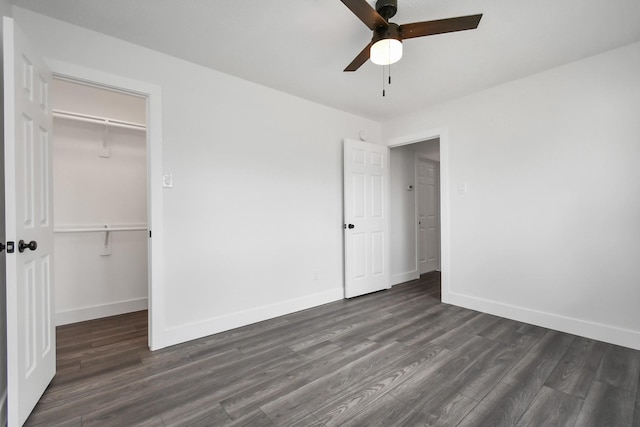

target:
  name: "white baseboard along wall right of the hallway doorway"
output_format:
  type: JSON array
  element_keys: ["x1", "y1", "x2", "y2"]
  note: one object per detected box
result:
[{"x1": 442, "y1": 289, "x2": 640, "y2": 350}]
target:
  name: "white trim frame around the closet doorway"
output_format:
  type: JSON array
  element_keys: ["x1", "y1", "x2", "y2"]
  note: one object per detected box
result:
[{"x1": 45, "y1": 58, "x2": 166, "y2": 350}]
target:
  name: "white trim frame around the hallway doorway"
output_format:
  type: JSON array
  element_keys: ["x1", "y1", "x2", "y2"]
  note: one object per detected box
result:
[{"x1": 386, "y1": 127, "x2": 451, "y2": 303}]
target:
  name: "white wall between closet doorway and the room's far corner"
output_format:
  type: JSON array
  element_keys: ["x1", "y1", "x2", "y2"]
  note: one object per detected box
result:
[{"x1": 14, "y1": 8, "x2": 380, "y2": 345}]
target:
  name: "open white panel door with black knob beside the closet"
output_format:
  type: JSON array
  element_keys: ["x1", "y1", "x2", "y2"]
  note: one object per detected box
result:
[{"x1": 3, "y1": 17, "x2": 56, "y2": 427}]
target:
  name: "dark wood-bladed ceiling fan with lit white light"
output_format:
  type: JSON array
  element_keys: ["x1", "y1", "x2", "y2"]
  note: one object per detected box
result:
[{"x1": 341, "y1": 0, "x2": 482, "y2": 71}]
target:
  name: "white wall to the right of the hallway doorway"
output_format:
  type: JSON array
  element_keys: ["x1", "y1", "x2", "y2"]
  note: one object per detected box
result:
[{"x1": 383, "y1": 43, "x2": 640, "y2": 349}]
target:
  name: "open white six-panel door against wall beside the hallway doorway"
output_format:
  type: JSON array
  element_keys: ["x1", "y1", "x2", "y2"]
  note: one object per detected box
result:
[{"x1": 344, "y1": 139, "x2": 391, "y2": 298}]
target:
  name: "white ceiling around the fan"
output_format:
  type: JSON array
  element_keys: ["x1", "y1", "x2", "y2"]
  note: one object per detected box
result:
[{"x1": 8, "y1": 0, "x2": 640, "y2": 120}]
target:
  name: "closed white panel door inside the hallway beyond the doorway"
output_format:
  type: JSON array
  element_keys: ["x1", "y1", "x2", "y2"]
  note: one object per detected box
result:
[{"x1": 416, "y1": 158, "x2": 440, "y2": 274}]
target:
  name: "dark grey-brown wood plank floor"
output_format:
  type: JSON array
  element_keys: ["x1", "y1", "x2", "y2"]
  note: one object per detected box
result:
[{"x1": 26, "y1": 274, "x2": 640, "y2": 427}]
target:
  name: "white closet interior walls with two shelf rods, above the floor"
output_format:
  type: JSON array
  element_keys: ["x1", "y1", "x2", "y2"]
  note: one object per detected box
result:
[{"x1": 51, "y1": 77, "x2": 150, "y2": 338}]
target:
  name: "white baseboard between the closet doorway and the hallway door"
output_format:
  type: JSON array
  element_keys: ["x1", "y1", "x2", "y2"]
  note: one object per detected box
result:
[{"x1": 164, "y1": 287, "x2": 344, "y2": 347}]
